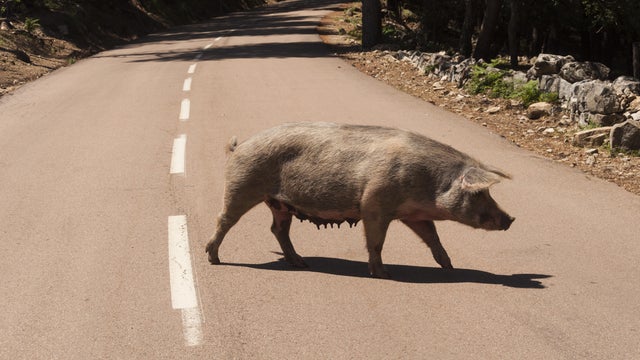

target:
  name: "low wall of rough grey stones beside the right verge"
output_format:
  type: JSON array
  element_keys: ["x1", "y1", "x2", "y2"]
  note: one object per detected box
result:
[{"x1": 394, "y1": 50, "x2": 640, "y2": 150}]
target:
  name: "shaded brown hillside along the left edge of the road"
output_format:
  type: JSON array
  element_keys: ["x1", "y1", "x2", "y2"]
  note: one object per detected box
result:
[{"x1": 0, "y1": 0, "x2": 264, "y2": 95}]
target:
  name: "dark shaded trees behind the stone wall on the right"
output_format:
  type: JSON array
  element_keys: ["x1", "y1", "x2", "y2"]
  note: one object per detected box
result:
[{"x1": 362, "y1": 0, "x2": 640, "y2": 75}]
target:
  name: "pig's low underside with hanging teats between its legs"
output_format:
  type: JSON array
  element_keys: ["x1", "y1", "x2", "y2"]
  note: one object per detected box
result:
[{"x1": 265, "y1": 197, "x2": 360, "y2": 229}]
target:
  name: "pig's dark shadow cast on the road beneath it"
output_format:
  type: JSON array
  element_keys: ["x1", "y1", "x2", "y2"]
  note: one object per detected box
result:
[{"x1": 223, "y1": 257, "x2": 551, "y2": 289}]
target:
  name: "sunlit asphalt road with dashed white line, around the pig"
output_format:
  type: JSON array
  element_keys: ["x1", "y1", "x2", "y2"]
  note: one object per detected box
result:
[{"x1": 0, "y1": 1, "x2": 640, "y2": 359}]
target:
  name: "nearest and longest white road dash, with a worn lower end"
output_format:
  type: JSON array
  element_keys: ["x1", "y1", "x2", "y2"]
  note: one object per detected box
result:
[{"x1": 168, "y1": 215, "x2": 203, "y2": 346}]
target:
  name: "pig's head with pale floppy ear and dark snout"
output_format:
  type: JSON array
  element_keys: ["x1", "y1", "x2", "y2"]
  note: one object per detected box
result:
[{"x1": 440, "y1": 166, "x2": 515, "y2": 230}]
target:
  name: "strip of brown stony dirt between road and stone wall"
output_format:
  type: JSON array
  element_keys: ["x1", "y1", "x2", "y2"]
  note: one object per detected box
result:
[{"x1": 319, "y1": 3, "x2": 640, "y2": 195}]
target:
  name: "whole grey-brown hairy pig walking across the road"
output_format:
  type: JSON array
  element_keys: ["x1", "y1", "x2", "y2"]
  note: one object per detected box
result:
[{"x1": 206, "y1": 123, "x2": 515, "y2": 278}]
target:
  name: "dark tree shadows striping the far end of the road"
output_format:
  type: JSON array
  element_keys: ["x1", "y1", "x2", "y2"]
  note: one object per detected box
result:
[{"x1": 95, "y1": 0, "x2": 352, "y2": 63}]
